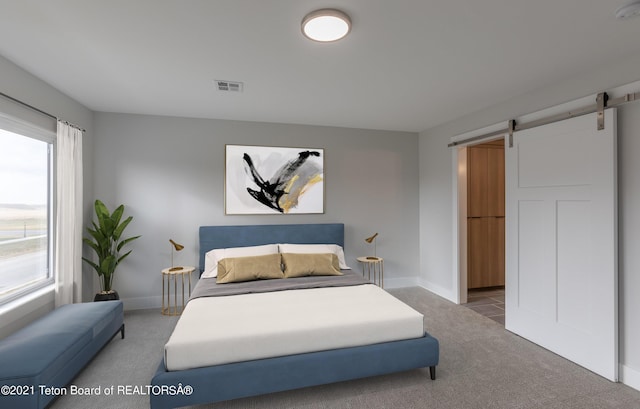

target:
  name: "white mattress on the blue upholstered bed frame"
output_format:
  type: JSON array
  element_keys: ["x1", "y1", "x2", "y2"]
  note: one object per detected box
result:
[{"x1": 165, "y1": 284, "x2": 424, "y2": 371}]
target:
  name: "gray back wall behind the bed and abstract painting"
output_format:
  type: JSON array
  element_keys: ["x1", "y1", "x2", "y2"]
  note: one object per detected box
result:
[{"x1": 94, "y1": 113, "x2": 419, "y2": 309}]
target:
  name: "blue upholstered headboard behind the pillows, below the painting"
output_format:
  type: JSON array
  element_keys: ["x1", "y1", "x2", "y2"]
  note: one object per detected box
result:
[{"x1": 200, "y1": 223, "x2": 344, "y2": 272}]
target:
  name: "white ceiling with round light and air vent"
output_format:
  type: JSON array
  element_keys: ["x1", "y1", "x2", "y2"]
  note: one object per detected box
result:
[{"x1": 0, "y1": 0, "x2": 640, "y2": 132}]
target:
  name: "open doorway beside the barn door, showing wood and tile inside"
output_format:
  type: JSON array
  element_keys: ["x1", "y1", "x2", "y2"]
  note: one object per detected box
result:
[{"x1": 458, "y1": 138, "x2": 505, "y2": 325}]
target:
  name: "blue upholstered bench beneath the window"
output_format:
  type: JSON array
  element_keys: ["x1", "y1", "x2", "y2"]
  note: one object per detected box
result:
[{"x1": 0, "y1": 301, "x2": 124, "y2": 409}]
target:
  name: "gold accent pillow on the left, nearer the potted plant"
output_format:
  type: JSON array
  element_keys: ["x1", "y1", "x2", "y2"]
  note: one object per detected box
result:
[{"x1": 216, "y1": 254, "x2": 284, "y2": 284}]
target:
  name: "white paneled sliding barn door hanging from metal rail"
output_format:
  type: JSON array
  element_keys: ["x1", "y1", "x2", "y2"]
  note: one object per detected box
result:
[{"x1": 505, "y1": 109, "x2": 618, "y2": 381}]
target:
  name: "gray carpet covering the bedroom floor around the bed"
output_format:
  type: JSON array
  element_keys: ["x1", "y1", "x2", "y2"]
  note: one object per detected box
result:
[{"x1": 52, "y1": 288, "x2": 640, "y2": 409}]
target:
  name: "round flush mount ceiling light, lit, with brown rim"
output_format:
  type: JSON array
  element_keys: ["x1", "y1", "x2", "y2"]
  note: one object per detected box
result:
[{"x1": 302, "y1": 9, "x2": 351, "y2": 43}]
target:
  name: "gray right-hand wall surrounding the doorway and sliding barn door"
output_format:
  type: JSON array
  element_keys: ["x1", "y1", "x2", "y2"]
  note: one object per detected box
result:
[{"x1": 419, "y1": 56, "x2": 640, "y2": 389}]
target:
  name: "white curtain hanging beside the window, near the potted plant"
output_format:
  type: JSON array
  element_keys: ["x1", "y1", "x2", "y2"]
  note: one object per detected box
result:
[{"x1": 55, "y1": 121, "x2": 82, "y2": 307}]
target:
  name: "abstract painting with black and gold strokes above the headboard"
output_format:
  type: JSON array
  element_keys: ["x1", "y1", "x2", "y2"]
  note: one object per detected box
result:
[{"x1": 225, "y1": 145, "x2": 324, "y2": 214}]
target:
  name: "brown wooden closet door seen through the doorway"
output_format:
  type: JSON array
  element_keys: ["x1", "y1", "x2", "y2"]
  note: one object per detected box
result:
[{"x1": 467, "y1": 140, "x2": 505, "y2": 288}]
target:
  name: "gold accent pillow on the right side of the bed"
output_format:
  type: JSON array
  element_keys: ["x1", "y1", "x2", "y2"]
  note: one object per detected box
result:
[{"x1": 282, "y1": 253, "x2": 342, "y2": 278}]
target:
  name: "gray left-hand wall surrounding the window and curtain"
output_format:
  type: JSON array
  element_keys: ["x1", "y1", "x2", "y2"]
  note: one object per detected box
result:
[{"x1": 0, "y1": 57, "x2": 93, "y2": 338}]
